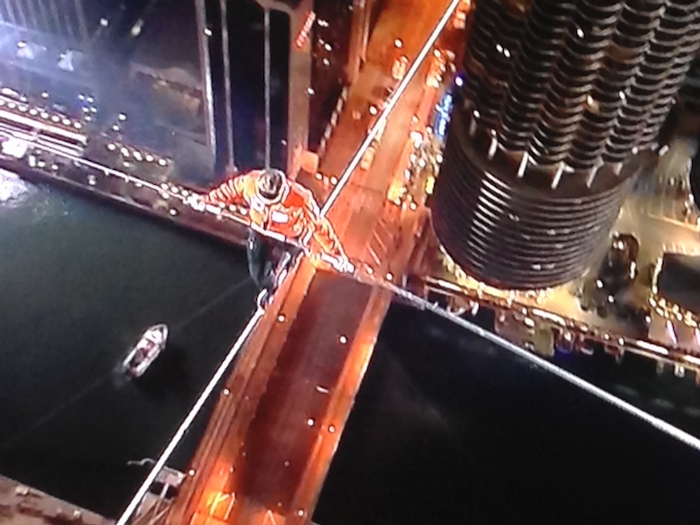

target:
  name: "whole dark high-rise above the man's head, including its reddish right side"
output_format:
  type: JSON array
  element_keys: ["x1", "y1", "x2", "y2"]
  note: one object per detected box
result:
[{"x1": 194, "y1": 0, "x2": 375, "y2": 176}]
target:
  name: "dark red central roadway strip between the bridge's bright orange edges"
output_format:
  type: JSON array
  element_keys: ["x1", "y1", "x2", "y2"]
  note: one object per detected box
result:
[{"x1": 230, "y1": 272, "x2": 372, "y2": 523}]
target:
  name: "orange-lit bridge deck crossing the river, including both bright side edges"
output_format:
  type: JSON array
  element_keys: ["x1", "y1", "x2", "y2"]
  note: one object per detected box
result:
[{"x1": 170, "y1": 265, "x2": 390, "y2": 525}]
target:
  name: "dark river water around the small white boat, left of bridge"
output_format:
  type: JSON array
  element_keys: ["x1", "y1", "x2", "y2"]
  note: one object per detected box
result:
[{"x1": 0, "y1": 173, "x2": 254, "y2": 516}]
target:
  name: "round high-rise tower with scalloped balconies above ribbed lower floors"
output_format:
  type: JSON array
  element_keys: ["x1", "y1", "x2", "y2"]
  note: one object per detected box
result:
[{"x1": 431, "y1": 0, "x2": 700, "y2": 289}]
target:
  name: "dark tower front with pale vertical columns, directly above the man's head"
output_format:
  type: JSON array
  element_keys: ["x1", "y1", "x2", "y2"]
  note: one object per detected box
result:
[{"x1": 195, "y1": 0, "x2": 315, "y2": 176}]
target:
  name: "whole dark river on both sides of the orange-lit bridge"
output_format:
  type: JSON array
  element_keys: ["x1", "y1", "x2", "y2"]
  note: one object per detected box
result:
[{"x1": 0, "y1": 173, "x2": 700, "y2": 525}]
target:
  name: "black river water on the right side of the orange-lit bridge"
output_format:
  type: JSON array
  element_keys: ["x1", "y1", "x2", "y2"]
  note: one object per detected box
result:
[{"x1": 314, "y1": 306, "x2": 700, "y2": 525}]
